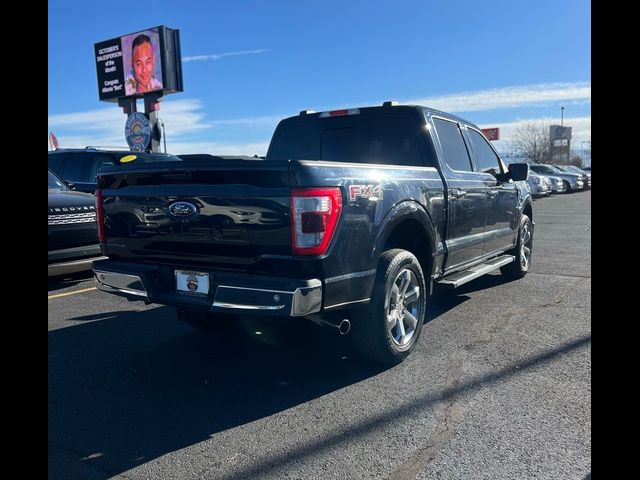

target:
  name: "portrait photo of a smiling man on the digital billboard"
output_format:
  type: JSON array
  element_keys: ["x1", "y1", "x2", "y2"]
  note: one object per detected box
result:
[{"x1": 122, "y1": 28, "x2": 162, "y2": 96}]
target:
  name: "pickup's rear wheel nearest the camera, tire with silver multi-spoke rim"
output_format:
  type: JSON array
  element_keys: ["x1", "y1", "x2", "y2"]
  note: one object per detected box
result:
[{"x1": 353, "y1": 249, "x2": 427, "y2": 365}]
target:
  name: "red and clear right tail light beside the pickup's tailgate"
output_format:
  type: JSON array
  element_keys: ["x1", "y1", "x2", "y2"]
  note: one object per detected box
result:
[{"x1": 291, "y1": 187, "x2": 342, "y2": 255}]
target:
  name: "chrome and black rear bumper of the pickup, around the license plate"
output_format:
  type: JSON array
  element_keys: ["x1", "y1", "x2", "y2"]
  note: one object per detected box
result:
[{"x1": 93, "y1": 260, "x2": 322, "y2": 317}]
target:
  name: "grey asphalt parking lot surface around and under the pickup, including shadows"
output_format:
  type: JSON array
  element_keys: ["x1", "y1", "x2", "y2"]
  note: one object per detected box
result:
[{"x1": 48, "y1": 191, "x2": 591, "y2": 480}]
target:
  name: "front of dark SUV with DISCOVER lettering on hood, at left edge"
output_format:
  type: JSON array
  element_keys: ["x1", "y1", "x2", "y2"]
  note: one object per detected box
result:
[{"x1": 47, "y1": 170, "x2": 104, "y2": 277}]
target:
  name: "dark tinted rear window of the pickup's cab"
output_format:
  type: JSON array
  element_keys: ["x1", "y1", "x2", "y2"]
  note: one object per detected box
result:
[{"x1": 267, "y1": 114, "x2": 434, "y2": 166}]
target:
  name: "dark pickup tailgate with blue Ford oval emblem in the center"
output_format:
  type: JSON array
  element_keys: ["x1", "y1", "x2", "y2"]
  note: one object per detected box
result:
[{"x1": 99, "y1": 160, "x2": 291, "y2": 270}]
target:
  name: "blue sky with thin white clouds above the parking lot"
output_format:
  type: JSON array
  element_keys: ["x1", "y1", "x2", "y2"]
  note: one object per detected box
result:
[{"x1": 47, "y1": 0, "x2": 591, "y2": 159}]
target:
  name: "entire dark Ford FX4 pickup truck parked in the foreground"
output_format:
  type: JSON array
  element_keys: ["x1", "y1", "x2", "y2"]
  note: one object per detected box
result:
[{"x1": 93, "y1": 102, "x2": 533, "y2": 363}]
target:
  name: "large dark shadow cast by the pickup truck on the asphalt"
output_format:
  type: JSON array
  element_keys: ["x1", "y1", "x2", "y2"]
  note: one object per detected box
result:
[{"x1": 48, "y1": 270, "x2": 520, "y2": 479}]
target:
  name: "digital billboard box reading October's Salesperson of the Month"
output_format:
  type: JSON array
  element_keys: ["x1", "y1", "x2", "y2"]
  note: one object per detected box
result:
[{"x1": 94, "y1": 26, "x2": 182, "y2": 102}]
